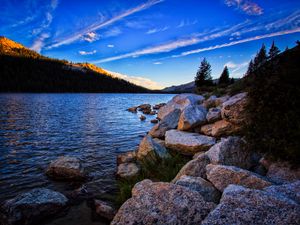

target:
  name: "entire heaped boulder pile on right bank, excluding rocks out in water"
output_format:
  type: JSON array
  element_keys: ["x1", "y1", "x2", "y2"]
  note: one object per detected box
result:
[{"x1": 111, "y1": 93, "x2": 300, "y2": 225}]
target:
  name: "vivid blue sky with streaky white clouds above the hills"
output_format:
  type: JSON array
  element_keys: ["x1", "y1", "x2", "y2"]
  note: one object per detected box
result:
[{"x1": 0, "y1": 0, "x2": 300, "y2": 89}]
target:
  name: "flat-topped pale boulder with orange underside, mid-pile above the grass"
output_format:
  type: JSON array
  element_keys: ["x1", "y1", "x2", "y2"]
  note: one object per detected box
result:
[{"x1": 165, "y1": 130, "x2": 216, "y2": 155}]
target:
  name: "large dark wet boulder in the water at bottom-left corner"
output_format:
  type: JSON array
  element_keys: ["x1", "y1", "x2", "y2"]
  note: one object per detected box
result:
[{"x1": 0, "y1": 188, "x2": 68, "y2": 225}]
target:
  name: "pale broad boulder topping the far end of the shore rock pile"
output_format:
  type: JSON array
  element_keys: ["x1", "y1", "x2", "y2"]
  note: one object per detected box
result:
[{"x1": 157, "y1": 94, "x2": 204, "y2": 120}]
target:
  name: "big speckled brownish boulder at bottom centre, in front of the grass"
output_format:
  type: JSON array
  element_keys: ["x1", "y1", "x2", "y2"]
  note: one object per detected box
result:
[{"x1": 111, "y1": 180, "x2": 216, "y2": 225}]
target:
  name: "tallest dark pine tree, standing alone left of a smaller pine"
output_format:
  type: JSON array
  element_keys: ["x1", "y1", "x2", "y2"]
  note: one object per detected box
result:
[{"x1": 195, "y1": 58, "x2": 212, "y2": 88}]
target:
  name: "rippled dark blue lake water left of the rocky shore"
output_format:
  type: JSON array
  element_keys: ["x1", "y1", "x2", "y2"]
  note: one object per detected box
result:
[{"x1": 0, "y1": 94, "x2": 173, "y2": 223}]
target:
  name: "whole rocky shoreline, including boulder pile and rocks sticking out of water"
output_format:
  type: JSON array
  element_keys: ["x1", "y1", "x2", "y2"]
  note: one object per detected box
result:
[{"x1": 0, "y1": 93, "x2": 300, "y2": 225}]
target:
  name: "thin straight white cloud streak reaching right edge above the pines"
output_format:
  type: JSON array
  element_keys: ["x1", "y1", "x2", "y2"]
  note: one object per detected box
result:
[{"x1": 172, "y1": 28, "x2": 300, "y2": 58}]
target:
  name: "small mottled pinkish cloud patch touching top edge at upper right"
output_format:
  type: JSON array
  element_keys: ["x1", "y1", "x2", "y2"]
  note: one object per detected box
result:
[{"x1": 225, "y1": 0, "x2": 263, "y2": 15}]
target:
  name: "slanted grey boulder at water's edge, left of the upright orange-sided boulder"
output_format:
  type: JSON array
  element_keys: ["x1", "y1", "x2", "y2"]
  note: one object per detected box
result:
[{"x1": 149, "y1": 109, "x2": 181, "y2": 138}]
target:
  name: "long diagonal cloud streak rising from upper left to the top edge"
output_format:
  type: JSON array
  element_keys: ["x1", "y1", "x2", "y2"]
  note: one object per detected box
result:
[{"x1": 47, "y1": 0, "x2": 164, "y2": 49}]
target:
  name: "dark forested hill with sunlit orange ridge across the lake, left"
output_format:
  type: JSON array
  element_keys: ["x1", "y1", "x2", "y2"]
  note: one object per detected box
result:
[{"x1": 0, "y1": 37, "x2": 150, "y2": 93}]
